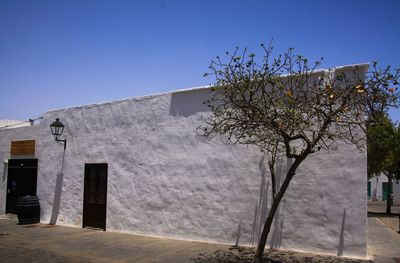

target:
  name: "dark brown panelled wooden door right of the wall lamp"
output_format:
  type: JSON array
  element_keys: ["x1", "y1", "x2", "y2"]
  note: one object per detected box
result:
[{"x1": 83, "y1": 163, "x2": 108, "y2": 230}]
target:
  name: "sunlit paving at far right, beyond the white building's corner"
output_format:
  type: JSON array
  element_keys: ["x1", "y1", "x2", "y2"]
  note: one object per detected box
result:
[{"x1": 368, "y1": 217, "x2": 400, "y2": 263}]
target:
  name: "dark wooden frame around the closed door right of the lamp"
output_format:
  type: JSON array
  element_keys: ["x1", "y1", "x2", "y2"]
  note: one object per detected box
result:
[{"x1": 82, "y1": 163, "x2": 108, "y2": 231}]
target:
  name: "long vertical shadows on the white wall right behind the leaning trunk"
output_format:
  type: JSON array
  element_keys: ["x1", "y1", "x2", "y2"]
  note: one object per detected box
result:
[{"x1": 250, "y1": 157, "x2": 291, "y2": 248}]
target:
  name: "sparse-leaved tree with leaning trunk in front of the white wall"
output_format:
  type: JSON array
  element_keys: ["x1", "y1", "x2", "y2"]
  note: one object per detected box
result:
[{"x1": 199, "y1": 45, "x2": 399, "y2": 262}]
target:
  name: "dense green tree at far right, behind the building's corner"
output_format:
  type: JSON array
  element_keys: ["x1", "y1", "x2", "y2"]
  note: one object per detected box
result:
[{"x1": 367, "y1": 113, "x2": 400, "y2": 214}]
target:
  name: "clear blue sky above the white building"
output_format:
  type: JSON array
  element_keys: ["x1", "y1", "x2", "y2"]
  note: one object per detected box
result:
[{"x1": 0, "y1": 0, "x2": 400, "y2": 120}]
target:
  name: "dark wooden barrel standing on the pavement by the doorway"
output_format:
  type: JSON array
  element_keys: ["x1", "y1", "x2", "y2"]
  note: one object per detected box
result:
[{"x1": 17, "y1": 195, "x2": 40, "y2": 225}]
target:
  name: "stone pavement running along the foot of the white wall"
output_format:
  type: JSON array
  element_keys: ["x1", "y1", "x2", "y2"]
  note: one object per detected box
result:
[{"x1": 0, "y1": 216, "x2": 388, "y2": 263}]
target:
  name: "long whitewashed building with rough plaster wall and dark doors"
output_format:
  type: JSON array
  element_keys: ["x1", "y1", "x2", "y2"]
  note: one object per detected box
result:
[{"x1": 0, "y1": 64, "x2": 368, "y2": 257}]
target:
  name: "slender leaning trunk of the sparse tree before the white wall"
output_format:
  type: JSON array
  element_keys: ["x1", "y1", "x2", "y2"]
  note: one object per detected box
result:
[{"x1": 253, "y1": 154, "x2": 308, "y2": 263}]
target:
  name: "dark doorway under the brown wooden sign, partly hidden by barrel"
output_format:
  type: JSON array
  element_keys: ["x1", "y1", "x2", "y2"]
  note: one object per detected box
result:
[{"x1": 6, "y1": 159, "x2": 38, "y2": 214}]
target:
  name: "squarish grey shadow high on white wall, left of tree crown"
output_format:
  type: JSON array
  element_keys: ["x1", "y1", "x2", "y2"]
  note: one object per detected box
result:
[{"x1": 169, "y1": 89, "x2": 210, "y2": 117}]
